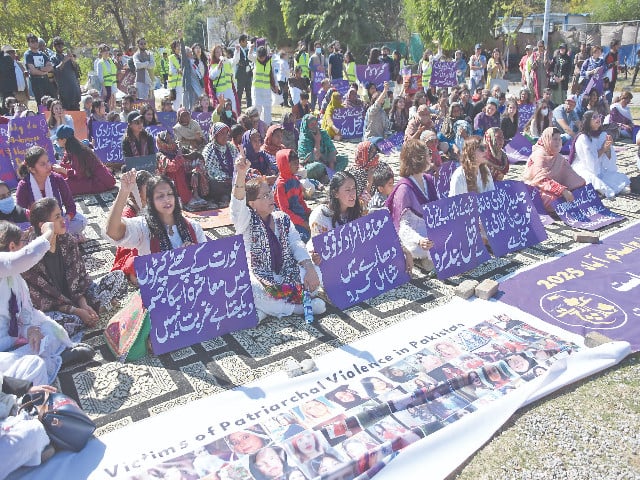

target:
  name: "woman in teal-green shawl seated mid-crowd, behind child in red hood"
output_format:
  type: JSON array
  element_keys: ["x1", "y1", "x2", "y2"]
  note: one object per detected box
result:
[{"x1": 298, "y1": 115, "x2": 348, "y2": 181}]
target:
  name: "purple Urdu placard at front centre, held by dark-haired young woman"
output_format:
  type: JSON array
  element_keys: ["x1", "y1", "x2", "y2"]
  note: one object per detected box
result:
[{"x1": 313, "y1": 209, "x2": 410, "y2": 310}]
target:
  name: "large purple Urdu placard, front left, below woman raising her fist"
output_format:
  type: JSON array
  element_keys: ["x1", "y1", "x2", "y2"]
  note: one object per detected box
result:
[{"x1": 134, "y1": 235, "x2": 258, "y2": 355}]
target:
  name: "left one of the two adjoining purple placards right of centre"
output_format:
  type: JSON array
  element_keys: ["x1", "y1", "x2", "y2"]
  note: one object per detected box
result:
[{"x1": 422, "y1": 193, "x2": 491, "y2": 280}]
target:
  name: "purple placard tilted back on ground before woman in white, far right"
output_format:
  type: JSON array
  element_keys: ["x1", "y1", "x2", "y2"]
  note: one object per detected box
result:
[{"x1": 552, "y1": 183, "x2": 626, "y2": 230}]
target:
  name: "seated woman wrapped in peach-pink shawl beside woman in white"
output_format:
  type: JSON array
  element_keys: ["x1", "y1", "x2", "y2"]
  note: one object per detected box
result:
[{"x1": 523, "y1": 127, "x2": 584, "y2": 212}]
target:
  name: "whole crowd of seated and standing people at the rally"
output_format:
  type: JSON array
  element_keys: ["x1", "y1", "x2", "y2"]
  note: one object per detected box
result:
[{"x1": 0, "y1": 28, "x2": 640, "y2": 478}]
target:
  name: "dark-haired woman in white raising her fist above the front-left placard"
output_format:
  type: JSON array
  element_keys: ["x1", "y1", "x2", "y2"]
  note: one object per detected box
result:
[{"x1": 106, "y1": 170, "x2": 207, "y2": 255}]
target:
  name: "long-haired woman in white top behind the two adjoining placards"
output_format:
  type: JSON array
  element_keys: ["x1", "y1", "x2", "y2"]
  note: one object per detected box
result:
[{"x1": 449, "y1": 135, "x2": 495, "y2": 197}]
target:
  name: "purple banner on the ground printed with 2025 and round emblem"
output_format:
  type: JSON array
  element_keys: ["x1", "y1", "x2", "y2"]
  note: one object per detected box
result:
[{"x1": 500, "y1": 220, "x2": 640, "y2": 352}]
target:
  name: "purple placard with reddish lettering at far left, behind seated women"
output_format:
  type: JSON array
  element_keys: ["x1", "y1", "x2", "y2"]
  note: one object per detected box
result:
[{"x1": 9, "y1": 114, "x2": 56, "y2": 165}]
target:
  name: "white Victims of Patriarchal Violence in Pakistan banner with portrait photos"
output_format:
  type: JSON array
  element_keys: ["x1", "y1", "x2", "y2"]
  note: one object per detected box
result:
[{"x1": 19, "y1": 299, "x2": 629, "y2": 480}]
